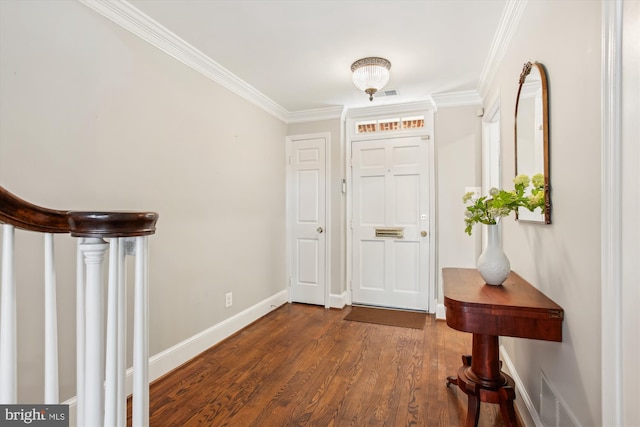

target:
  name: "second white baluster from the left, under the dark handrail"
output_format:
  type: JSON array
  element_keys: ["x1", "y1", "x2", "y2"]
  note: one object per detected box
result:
[{"x1": 44, "y1": 233, "x2": 60, "y2": 404}]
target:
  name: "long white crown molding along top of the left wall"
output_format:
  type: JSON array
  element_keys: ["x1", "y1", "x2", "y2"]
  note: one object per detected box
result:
[{"x1": 78, "y1": 0, "x2": 289, "y2": 122}]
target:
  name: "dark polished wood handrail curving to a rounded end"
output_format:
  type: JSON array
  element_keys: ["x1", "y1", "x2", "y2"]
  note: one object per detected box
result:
[{"x1": 0, "y1": 186, "x2": 158, "y2": 237}]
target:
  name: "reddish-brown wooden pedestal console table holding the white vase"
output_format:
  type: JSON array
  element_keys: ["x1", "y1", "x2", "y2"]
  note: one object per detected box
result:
[{"x1": 442, "y1": 268, "x2": 564, "y2": 427}]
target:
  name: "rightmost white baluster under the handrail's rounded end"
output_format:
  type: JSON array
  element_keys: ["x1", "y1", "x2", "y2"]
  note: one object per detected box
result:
[{"x1": 132, "y1": 236, "x2": 149, "y2": 427}]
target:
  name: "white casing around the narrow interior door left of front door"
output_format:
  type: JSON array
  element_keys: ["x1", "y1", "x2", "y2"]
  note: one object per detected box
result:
[{"x1": 285, "y1": 132, "x2": 332, "y2": 308}]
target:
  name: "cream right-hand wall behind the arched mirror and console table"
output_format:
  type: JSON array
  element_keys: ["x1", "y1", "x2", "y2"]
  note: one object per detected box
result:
[{"x1": 487, "y1": 0, "x2": 602, "y2": 426}]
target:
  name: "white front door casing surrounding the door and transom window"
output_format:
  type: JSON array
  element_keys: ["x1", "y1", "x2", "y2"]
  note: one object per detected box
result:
[{"x1": 345, "y1": 103, "x2": 438, "y2": 313}]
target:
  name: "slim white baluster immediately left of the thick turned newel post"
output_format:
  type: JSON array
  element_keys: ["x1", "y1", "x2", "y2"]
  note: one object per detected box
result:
[{"x1": 76, "y1": 238, "x2": 86, "y2": 426}]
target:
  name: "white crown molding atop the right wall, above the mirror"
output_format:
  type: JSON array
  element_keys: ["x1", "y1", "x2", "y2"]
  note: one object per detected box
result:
[{"x1": 478, "y1": 0, "x2": 528, "y2": 98}]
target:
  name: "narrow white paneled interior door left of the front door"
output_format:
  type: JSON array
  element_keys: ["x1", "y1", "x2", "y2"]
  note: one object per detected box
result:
[{"x1": 288, "y1": 137, "x2": 327, "y2": 305}]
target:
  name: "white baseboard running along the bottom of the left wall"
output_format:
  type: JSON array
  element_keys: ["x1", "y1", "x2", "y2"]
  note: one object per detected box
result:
[{"x1": 63, "y1": 289, "x2": 289, "y2": 427}]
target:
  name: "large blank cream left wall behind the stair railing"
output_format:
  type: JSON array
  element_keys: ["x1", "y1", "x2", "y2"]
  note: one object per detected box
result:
[{"x1": 0, "y1": 0, "x2": 286, "y2": 401}]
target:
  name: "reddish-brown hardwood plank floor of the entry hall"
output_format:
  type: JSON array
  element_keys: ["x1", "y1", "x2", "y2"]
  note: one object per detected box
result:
[{"x1": 129, "y1": 304, "x2": 516, "y2": 427}]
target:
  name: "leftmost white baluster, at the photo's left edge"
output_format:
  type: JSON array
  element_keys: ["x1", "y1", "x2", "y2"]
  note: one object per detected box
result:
[{"x1": 0, "y1": 224, "x2": 18, "y2": 405}]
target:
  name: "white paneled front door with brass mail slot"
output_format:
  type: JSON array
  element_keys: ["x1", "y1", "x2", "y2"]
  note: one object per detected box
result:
[{"x1": 351, "y1": 137, "x2": 430, "y2": 310}]
